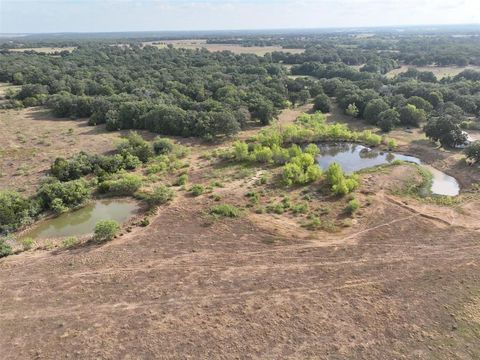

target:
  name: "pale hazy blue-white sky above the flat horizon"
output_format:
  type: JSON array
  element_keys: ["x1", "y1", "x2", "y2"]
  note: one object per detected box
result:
[{"x1": 0, "y1": 0, "x2": 480, "y2": 33}]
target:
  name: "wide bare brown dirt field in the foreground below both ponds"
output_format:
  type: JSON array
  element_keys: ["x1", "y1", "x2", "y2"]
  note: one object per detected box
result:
[{"x1": 0, "y1": 105, "x2": 480, "y2": 360}]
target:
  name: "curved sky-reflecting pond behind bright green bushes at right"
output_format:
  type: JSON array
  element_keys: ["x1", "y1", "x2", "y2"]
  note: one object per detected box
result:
[{"x1": 316, "y1": 143, "x2": 460, "y2": 196}]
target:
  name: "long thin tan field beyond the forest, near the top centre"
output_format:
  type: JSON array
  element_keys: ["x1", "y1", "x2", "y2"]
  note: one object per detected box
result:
[{"x1": 143, "y1": 39, "x2": 305, "y2": 56}]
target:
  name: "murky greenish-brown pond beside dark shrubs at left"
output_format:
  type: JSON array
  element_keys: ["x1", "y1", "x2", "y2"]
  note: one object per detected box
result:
[{"x1": 23, "y1": 199, "x2": 139, "y2": 239}]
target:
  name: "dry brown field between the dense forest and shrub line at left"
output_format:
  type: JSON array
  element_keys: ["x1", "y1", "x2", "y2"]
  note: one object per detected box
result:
[{"x1": 0, "y1": 108, "x2": 120, "y2": 193}]
